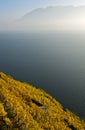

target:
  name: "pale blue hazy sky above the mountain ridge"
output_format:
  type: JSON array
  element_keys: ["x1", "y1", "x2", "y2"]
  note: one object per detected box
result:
[{"x1": 0, "y1": 0, "x2": 85, "y2": 20}]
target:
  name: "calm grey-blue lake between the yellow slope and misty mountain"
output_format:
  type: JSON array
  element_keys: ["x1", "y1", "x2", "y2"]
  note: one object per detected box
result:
[{"x1": 0, "y1": 32, "x2": 85, "y2": 119}]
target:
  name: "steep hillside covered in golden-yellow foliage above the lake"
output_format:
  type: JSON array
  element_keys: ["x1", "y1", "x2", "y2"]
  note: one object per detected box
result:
[{"x1": 0, "y1": 72, "x2": 85, "y2": 130}]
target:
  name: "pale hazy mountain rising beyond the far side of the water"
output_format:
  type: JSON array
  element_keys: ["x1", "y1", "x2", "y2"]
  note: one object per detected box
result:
[{"x1": 12, "y1": 6, "x2": 85, "y2": 30}]
